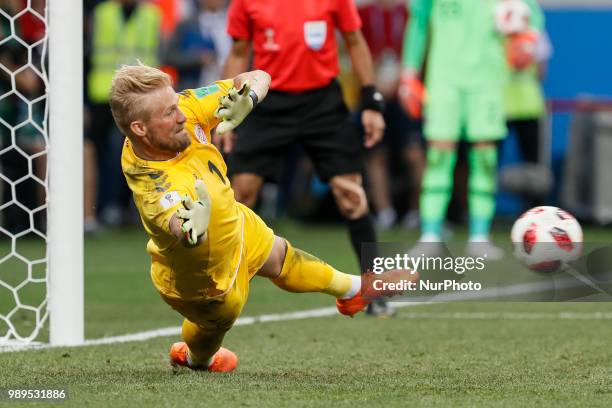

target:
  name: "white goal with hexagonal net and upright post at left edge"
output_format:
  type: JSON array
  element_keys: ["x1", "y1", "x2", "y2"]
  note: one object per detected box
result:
[{"x1": 0, "y1": 0, "x2": 83, "y2": 349}]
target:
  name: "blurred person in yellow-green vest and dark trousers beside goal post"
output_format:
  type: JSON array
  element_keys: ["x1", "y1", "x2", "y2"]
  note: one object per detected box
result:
[{"x1": 85, "y1": 0, "x2": 161, "y2": 231}]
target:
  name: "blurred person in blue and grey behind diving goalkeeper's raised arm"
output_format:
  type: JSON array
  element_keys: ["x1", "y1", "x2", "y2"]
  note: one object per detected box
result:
[{"x1": 164, "y1": 0, "x2": 232, "y2": 89}]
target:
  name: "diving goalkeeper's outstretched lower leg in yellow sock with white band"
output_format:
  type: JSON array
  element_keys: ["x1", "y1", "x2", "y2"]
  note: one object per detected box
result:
[{"x1": 271, "y1": 240, "x2": 361, "y2": 299}]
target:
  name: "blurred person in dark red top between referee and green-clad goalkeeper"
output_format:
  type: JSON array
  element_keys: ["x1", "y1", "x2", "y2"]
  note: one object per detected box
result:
[{"x1": 359, "y1": 0, "x2": 425, "y2": 229}]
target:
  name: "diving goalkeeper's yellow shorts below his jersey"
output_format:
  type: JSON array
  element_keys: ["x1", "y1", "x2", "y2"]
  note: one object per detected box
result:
[{"x1": 160, "y1": 204, "x2": 274, "y2": 331}]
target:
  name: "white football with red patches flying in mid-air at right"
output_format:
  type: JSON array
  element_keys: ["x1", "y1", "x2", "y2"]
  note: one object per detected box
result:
[{"x1": 511, "y1": 206, "x2": 582, "y2": 273}]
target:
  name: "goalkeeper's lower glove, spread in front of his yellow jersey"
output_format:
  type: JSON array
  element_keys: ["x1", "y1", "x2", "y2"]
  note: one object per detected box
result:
[{"x1": 176, "y1": 180, "x2": 211, "y2": 246}]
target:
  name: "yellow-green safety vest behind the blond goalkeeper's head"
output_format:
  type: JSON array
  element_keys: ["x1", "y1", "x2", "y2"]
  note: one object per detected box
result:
[{"x1": 87, "y1": 0, "x2": 161, "y2": 103}]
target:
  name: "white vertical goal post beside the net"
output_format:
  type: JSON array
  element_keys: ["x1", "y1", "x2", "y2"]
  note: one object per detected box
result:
[{"x1": 47, "y1": 0, "x2": 84, "y2": 345}]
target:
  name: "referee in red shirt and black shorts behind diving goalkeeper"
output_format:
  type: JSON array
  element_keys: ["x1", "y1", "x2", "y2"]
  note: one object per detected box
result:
[{"x1": 218, "y1": 0, "x2": 393, "y2": 316}]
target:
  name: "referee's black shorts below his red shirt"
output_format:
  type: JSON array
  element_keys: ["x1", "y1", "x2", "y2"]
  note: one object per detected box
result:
[{"x1": 229, "y1": 80, "x2": 363, "y2": 181}]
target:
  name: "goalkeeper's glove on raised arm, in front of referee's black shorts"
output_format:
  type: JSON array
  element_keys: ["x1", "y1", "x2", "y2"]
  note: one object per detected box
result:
[{"x1": 215, "y1": 81, "x2": 255, "y2": 135}]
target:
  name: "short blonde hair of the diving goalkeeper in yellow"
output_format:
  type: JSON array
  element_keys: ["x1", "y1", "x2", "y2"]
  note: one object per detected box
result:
[{"x1": 109, "y1": 63, "x2": 172, "y2": 136}]
